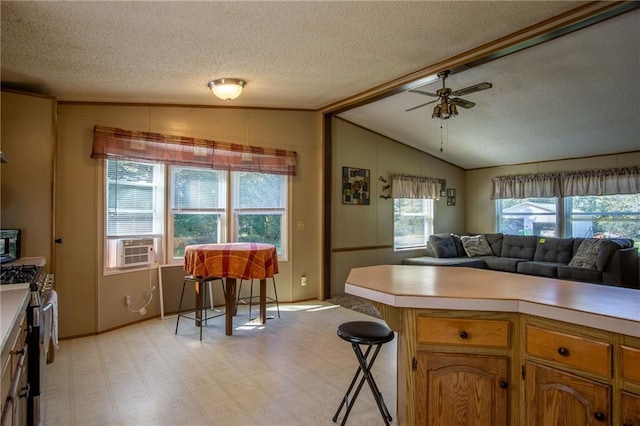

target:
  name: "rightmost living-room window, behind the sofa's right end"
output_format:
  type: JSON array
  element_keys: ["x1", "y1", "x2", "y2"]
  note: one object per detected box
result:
[{"x1": 565, "y1": 194, "x2": 640, "y2": 245}]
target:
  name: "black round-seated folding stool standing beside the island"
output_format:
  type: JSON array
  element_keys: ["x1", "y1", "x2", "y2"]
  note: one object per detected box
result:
[{"x1": 333, "y1": 321, "x2": 394, "y2": 426}]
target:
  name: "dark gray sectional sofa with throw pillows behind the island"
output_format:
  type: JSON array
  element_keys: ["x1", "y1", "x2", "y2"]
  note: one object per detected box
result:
[{"x1": 402, "y1": 233, "x2": 640, "y2": 288}]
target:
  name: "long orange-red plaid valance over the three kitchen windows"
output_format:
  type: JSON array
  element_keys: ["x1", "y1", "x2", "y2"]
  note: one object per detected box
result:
[{"x1": 91, "y1": 126, "x2": 297, "y2": 176}]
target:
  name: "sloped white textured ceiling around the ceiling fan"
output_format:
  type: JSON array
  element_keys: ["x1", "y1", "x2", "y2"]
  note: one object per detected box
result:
[{"x1": 340, "y1": 10, "x2": 640, "y2": 169}]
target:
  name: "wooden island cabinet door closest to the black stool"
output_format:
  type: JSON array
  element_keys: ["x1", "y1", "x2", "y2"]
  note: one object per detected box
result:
[{"x1": 416, "y1": 351, "x2": 509, "y2": 426}]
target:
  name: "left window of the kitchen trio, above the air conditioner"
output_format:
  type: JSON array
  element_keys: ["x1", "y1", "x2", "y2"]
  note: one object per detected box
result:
[{"x1": 105, "y1": 160, "x2": 164, "y2": 268}]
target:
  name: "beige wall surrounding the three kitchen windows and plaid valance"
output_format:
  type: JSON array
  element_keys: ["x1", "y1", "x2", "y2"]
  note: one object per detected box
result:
[{"x1": 57, "y1": 105, "x2": 322, "y2": 337}]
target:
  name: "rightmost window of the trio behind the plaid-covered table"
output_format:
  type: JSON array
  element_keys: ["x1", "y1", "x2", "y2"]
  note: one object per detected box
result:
[{"x1": 232, "y1": 172, "x2": 287, "y2": 256}]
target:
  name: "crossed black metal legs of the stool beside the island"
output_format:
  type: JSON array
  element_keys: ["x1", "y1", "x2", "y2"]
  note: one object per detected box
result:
[{"x1": 333, "y1": 343, "x2": 392, "y2": 426}]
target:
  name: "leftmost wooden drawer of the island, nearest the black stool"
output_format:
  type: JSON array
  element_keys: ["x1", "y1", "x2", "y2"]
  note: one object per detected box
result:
[{"x1": 417, "y1": 317, "x2": 509, "y2": 348}]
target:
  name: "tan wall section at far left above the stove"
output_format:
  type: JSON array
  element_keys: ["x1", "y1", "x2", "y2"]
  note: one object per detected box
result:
[{"x1": 0, "y1": 91, "x2": 55, "y2": 270}]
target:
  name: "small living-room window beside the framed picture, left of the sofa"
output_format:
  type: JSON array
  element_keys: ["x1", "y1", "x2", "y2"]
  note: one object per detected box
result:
[{"x1": 393, "y1": 198, "x2": 433, "y2": 250}]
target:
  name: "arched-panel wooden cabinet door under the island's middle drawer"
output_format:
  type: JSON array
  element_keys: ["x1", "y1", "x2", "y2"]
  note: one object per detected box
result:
[{"x1": 525, "y1": 362, "x2": 611, "y2": 426}]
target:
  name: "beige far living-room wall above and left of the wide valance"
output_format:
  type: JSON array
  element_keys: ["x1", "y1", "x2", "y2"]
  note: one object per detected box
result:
[{"x1": 465, "y1": 151, "x2": 640, "y2": 232}]
